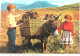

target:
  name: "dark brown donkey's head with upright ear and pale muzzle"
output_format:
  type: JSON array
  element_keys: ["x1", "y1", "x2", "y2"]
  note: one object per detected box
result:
[{"x1": 48, "y1": 14, "x2": 61, "y2": 37}]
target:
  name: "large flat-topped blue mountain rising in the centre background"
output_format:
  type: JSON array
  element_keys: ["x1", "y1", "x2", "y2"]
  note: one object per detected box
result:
[{"x1": 19, "y1": 1, "x2": 58, "y2": 10}]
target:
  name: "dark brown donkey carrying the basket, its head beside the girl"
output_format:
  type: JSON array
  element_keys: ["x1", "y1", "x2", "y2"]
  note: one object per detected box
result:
[{"x1": 22, "y1": 15, "x2": 60, "y2": 52}]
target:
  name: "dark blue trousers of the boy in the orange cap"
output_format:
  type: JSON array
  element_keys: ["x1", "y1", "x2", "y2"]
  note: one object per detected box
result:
[{"x1": 7, "y1": 28, "x2": 16, "y2": 53}]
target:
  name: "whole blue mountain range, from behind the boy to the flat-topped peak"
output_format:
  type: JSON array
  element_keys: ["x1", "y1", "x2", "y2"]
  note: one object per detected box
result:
[{"x1": 1, "y1": 1, "x2": 58, "y2": 11}]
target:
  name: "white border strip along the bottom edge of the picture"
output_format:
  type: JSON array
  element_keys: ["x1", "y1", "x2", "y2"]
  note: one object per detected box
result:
[{"x1": 0, "y1": 54, "x2": 80, "y2": 56}]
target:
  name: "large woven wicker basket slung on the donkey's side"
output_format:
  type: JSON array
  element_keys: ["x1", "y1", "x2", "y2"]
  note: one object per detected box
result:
[{"x1": 20, "y1": 19, "x2": 44, "y2": 37}]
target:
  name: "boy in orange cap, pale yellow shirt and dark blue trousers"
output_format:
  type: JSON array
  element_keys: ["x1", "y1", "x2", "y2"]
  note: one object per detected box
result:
[{"x1": 6, "y1": 4, "x2": 23, "y2": 53}]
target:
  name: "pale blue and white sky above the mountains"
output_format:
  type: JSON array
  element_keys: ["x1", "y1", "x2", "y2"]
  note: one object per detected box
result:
[{"x1": 1, "y1": 0, "x2": 80, "y2": 6}]
